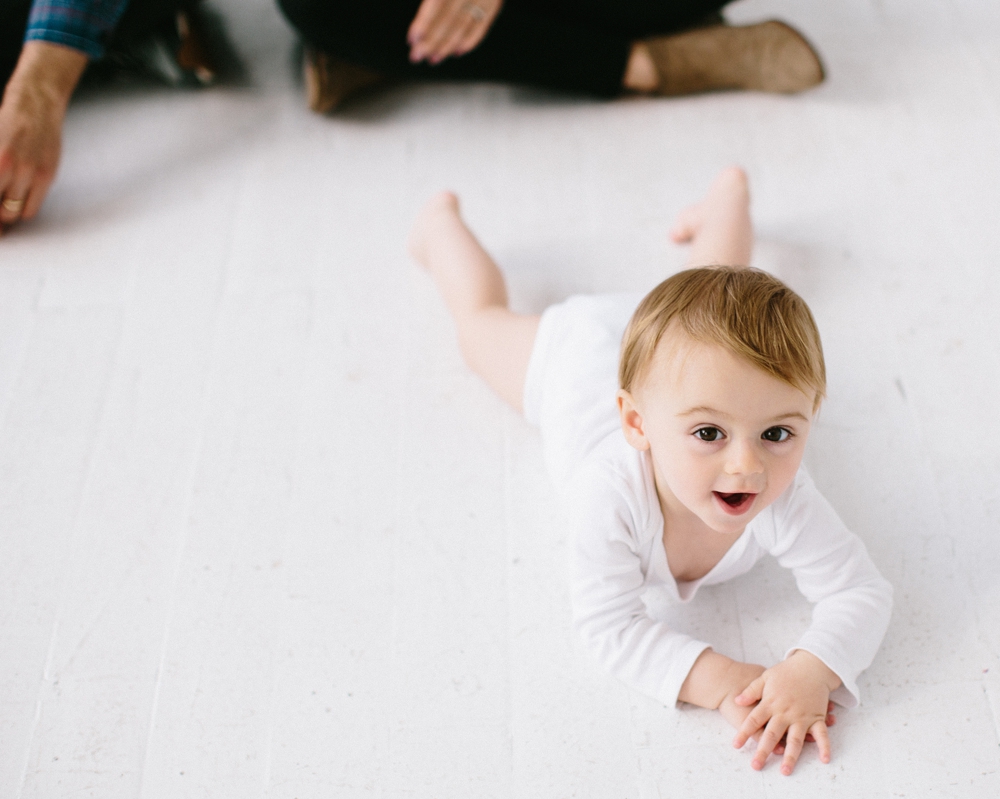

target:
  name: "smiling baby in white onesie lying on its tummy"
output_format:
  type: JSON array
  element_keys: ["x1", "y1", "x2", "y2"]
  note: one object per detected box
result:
[{"x1": 409, "y1": 168, "x2": 892, "y2": 774}]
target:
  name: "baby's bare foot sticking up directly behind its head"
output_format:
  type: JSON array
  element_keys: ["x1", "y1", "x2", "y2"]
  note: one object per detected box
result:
[{"x1": 670, "y1": 166, "x2": 753, "y2": 266}]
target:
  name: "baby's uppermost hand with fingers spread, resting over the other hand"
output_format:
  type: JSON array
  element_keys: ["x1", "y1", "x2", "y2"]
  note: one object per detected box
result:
[{"x1": 733, "y1": 649, "x2": 840, "y2": 775}]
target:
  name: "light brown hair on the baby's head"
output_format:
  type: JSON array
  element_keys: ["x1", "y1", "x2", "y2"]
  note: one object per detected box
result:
[{"x1": 618, "y1": 266, "x2": 826, "y2": 410}]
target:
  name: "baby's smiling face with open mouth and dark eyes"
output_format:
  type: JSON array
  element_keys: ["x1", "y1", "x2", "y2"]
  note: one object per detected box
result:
[{"x1": 619, "y1": 333, "x2": 814, "y2": 534}]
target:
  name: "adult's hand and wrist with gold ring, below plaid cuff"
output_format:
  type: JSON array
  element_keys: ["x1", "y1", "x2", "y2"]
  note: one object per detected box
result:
[{"x1": 0, "y1": 42, "x2": 87, "y2": 232}]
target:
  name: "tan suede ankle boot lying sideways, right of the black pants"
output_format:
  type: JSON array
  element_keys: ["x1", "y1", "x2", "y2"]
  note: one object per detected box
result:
[{"x1": 644, "y1": 20, "x2": 824, "y2": 95}]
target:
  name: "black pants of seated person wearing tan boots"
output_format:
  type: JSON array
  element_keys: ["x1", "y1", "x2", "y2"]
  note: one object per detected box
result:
[{"x1": 278, "y1": 0, "x2": 730, "y2": 97}]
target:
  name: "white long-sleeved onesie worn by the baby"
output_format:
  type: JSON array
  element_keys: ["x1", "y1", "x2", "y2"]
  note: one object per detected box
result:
[{"x1": 524, "y1": 295, "x2": 892, "y2": 707}]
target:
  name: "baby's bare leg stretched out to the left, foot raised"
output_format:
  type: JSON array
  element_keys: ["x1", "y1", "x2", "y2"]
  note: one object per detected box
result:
[{"x1": 409, "y1": 192, "x2": 539, "y2": 411}]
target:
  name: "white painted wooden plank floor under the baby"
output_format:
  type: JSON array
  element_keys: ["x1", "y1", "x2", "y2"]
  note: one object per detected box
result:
[{"x1": 0, "y1": 0, "x2": 1000, "y2": 799}]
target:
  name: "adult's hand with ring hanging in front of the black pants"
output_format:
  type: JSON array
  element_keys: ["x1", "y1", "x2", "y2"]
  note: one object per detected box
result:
[{"x1": 406, "y1": 0, "x2": 503, "y2": 64}]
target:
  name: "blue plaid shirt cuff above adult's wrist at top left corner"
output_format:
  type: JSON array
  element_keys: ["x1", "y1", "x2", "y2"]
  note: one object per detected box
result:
[{"x1": 24, "y1": 0, "x2": 129, "y2": 59}]
